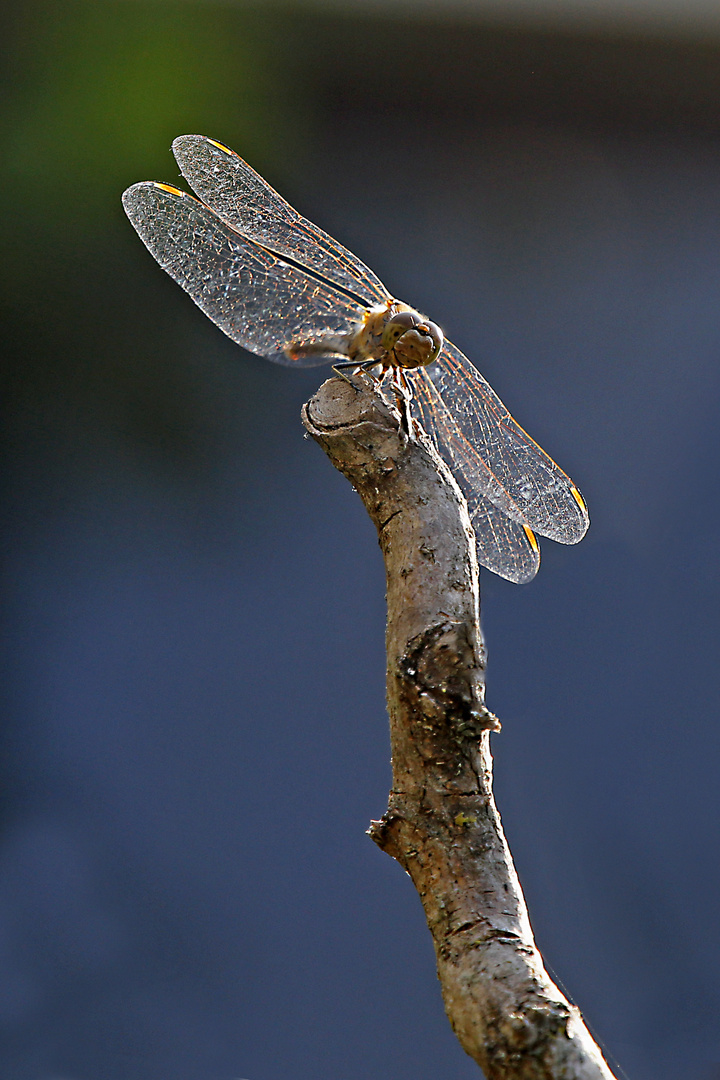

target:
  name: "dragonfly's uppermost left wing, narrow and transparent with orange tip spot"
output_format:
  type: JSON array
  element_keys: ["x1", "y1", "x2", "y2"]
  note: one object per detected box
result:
[{"x1": 173, "y1": 135, "x2": 390, "y2": 305}]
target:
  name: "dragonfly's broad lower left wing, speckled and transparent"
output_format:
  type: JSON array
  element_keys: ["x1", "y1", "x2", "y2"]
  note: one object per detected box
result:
[{"x1": 123, "y1": 180, "x2": 363, "y2": 366}]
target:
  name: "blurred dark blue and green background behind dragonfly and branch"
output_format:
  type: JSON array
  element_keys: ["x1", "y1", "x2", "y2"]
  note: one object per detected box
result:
[{"x1": 0, "y1": 0, "x2": 720, "y2": 1080}]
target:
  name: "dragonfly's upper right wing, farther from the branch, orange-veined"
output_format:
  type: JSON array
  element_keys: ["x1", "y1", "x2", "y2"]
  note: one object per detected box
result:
[{"x1": 427, "y1": 341, "x2": 589, "y2": 543}]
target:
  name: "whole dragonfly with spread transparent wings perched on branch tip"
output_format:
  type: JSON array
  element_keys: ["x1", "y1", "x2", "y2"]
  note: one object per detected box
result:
[{"x1": 123, "y1": 135, "x2": 589, "y2": 583}]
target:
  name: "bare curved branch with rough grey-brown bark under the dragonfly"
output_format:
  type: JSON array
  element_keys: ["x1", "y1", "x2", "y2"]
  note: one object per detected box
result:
[{"x1": 302, "y1": 379, "x2": 612, "y2": 1080}]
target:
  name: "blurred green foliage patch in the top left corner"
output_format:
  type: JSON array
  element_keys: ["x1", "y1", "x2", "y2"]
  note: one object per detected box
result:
[{"x1": 0, "y1": 0, "x2": 302, "y2": 248}]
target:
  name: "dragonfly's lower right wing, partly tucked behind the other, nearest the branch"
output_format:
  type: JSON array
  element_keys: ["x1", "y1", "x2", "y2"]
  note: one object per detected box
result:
[{"x1": 406, "y1": 368, "x2": 540, "y2": 584}]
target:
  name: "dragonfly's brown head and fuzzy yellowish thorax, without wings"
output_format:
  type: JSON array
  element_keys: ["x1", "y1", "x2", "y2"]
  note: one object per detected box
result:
[{"x1": 349, "y1": 300, "x2": 444, "y2": 368}]
